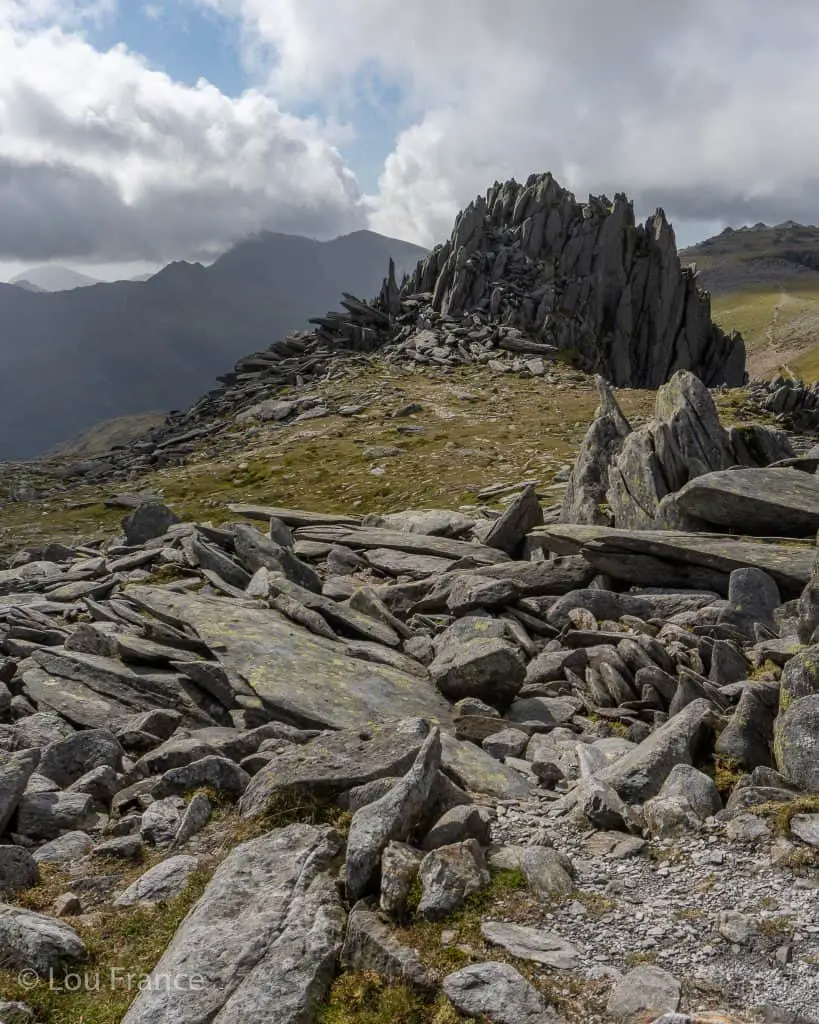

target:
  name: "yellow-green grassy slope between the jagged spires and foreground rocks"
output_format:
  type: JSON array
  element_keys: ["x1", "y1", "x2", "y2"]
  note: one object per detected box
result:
[{"x1": 0, "y1": 360, "x2": 761, "y2": 554}]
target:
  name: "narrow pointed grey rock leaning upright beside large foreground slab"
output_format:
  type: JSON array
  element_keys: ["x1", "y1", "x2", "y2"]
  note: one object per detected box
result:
[{"x1": 345, "y1": 729, "x2": 441, "y2": 903}]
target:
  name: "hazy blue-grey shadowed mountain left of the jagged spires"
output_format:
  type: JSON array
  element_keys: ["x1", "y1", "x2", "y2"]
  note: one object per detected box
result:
[{"x1": 0, "y1": 231, "x2": 426, "y2": 460}]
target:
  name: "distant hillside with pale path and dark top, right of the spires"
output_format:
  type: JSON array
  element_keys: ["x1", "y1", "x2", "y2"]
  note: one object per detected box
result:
[{"x1": 680, "y1": 221, "x2": 819, "y2": 379}]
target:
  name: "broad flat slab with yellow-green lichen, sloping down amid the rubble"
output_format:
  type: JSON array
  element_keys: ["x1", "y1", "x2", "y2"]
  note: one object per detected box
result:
[{"x1": 124, "y1": 587, "x2": 450, "y2": 729}]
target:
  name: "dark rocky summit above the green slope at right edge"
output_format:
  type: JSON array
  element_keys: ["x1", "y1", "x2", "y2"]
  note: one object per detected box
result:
[{"x1": 680, "y1": 220, "x2": 819, "y2": 295}]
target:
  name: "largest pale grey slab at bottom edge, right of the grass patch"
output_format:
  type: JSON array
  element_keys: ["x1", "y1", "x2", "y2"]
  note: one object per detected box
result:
[{"x1": 123, "y1": 824, "x2": 345, "y2": 1024}]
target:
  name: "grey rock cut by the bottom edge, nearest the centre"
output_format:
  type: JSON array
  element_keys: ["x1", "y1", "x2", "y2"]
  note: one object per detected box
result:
[{"x1": 443, "y1": 961, "x2": 559, "y2": 1024}]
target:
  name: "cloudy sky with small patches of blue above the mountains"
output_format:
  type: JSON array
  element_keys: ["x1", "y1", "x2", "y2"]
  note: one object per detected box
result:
[{"x1": 0, "y1": 0, "x2": 819, "y2": 280}]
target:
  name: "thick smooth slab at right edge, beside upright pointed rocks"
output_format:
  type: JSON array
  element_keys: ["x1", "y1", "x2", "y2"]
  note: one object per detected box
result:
[{"x1": 675, "y1": 468, "x2": 819, "y2": 537}]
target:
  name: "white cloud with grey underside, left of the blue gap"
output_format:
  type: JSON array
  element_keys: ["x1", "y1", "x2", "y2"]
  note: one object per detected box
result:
[{"x1": 0, "y1": 0, "x2": 363, "y2": 261}]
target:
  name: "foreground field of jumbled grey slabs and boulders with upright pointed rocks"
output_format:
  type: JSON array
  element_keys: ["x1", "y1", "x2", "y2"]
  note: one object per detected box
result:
[{"x1": 0, "y1": 452, "x2": 819, "y2": 1024}]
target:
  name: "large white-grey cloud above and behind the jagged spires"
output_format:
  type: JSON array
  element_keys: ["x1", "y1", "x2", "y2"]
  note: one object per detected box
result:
[{"x1": 200, "y1": 0, "x2": 819, "y2": 243}]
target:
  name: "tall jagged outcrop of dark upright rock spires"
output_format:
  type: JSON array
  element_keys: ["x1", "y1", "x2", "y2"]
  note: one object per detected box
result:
[{"x1": 313, "y1": 174, "x2": 745, "y2": 388}]
